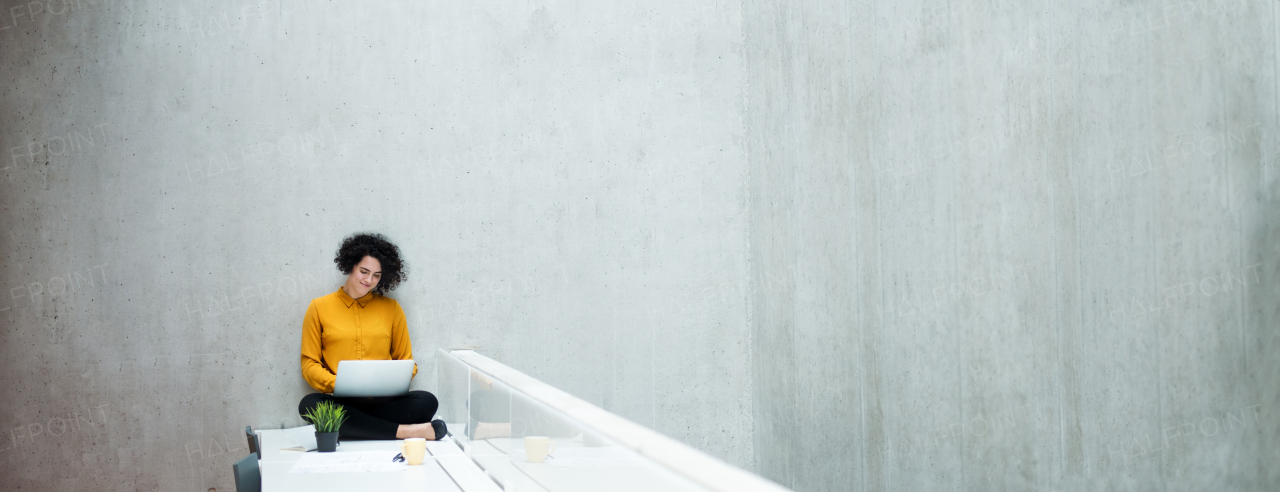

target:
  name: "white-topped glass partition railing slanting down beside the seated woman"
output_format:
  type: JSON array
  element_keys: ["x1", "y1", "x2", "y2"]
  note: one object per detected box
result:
[{"x1": 436, "y1": 350, "x2": 787, "y2": 492}]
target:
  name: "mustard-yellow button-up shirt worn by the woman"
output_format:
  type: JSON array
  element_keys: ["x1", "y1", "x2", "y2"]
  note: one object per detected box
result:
[{"x1": 302, "y1": 288, "x2": 417, "y2": 393}]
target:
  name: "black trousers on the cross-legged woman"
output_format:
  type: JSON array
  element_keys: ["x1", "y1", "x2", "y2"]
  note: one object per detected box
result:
[{"x1": 298, "y1": 391, "x2": 440, "y2": 441}]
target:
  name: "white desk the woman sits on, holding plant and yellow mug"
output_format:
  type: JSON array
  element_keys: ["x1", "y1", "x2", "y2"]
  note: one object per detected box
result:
[{"x1": 257, "y1": 427, "x2": 500, "y2": 492}]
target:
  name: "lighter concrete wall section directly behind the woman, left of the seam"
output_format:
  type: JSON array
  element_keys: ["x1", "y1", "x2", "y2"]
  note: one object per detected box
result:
[{"x1": 0, "y1": 0, "x2": 753, "y2": 492}]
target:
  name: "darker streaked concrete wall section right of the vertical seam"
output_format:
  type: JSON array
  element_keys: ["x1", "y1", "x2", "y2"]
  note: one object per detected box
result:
[{"x1": 744, "y1": 0, "x2": 1280, "y2": 491}]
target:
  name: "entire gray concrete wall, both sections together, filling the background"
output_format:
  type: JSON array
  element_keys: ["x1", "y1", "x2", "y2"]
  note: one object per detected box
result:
[{"x1": 0, "y1": 0, "x2": 1280, "y2": 491}]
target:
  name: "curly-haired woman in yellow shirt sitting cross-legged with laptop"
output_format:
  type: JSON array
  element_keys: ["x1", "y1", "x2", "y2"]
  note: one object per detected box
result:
[{"x1": 298, "y1": 234, "x2": 445, "y2": 439}]
